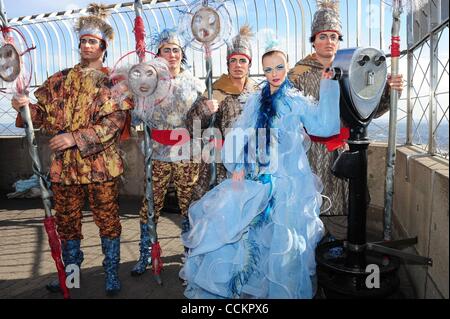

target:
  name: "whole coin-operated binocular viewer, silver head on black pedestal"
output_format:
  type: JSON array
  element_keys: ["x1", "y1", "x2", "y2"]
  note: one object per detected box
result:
[{"x1": 316, "y1": 48, "x2": 431, "y2": 298}]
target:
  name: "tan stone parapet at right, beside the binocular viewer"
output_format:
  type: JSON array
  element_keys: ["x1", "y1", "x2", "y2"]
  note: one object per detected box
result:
[{"x1": 368, "y1": 143, "x2": 449, "y2": 299}]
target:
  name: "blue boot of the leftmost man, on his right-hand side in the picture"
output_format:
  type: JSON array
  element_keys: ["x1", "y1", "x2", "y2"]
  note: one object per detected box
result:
[{"x1": 102, "y1": 237, "x2": 121, "y2": 296}]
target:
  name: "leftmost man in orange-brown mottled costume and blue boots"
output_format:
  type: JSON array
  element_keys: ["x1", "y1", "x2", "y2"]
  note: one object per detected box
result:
[{"x1": 12, "y1": 4, "x2": 131, "y2": 295}]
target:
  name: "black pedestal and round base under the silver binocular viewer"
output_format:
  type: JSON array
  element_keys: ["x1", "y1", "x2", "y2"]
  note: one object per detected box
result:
[{"x1": 316, "y1": 127, "x2": 432, "y2": 298}]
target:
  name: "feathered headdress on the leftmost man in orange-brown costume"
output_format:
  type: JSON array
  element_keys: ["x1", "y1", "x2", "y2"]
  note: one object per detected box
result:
[{"x1": 75, "y1": 3, "x2": 114, "y2": 43}]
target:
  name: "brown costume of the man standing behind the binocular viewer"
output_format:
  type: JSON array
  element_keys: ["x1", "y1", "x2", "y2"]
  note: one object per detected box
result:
[{"x1": 288, "y1": 53, "x2": 390, "y2": 239}]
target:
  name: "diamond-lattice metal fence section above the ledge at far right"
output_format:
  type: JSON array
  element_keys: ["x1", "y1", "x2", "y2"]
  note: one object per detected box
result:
[{"x1": 406, "y1": 19, "x2": 449, "y2": 159}]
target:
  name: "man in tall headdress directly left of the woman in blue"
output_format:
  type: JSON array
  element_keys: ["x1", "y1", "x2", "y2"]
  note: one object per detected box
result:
[{"x1": 187, "y1": 26, "x2": 256, "y2": 201}]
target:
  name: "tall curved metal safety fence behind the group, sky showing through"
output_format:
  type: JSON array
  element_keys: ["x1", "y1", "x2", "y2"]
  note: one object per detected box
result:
[{"x1": 0, "y1": 0, "x2": 448, "y2": 157}]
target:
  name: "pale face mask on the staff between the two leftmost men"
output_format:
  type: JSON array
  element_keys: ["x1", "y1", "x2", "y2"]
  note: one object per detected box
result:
[{"x1": 128, "y1": 63, "x2": 158, "y2": 98}]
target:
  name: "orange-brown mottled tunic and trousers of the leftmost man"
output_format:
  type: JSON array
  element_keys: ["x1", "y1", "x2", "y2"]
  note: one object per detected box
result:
[{"x1": 17, "y1": 64, "x2": 131, "y2": 240}]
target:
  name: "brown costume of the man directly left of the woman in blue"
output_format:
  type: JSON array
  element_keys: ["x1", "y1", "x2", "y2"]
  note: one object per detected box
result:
[{"x1": 187, "y1": 74, "x2": 256, "y2": 201}]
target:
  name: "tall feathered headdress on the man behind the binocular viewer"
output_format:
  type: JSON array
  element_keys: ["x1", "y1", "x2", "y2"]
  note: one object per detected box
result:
[{"x1": 311, "y1": 0, "x2": 342, "y2": 36}]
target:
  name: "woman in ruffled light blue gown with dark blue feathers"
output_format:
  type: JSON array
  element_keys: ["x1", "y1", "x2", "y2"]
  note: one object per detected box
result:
[{"x1": 180, "y1": 43, "x2": 340, "y2": 299}]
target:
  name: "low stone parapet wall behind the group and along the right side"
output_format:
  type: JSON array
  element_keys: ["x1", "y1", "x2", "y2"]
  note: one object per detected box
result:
[{"x1": 0, "y1": 134, "x2": 449, "y2": 298}]
